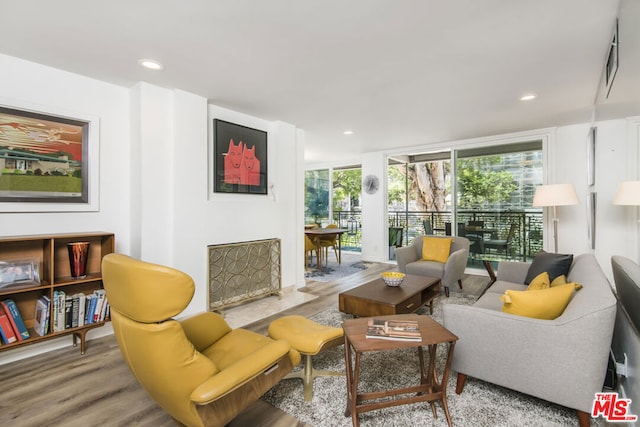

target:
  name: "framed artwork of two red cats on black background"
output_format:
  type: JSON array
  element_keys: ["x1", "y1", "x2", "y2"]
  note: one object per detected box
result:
[{"x1": 213, "y1": 119, "x2": 267, "y2": 195}]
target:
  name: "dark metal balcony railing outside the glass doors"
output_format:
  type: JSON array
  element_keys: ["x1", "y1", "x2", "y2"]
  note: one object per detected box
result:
[{"x1": 333, "y1": 210, "x2": 542, "y2": 260}]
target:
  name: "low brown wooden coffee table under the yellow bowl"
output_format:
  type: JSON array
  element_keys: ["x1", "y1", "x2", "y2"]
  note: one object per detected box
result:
[{"x1": 338, "y1": 274, "x2": 442, "y2": 317}]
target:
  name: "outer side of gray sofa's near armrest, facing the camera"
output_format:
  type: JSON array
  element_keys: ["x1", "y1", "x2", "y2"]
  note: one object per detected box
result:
[{"x1": 443, "y1": 304, "x2": 615, "y2": 412}]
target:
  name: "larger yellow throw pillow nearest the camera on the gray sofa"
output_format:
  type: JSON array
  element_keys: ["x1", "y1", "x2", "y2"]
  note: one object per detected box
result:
[{"x1": 500, "y1": 283, "x2": 575, "y2": 320}]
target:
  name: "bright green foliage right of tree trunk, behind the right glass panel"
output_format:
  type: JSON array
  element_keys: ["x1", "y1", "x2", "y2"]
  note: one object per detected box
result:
[{"x1": 458, "y1": 156, "x2": 518, "y2": 209}]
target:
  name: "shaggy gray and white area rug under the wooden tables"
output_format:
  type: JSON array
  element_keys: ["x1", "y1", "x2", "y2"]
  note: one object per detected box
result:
[{"x1": 263, "y1": 292, "x2": 603, "y2": 427}]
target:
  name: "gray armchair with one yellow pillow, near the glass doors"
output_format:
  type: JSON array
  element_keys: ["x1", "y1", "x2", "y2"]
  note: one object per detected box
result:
[{"x1": 396, "y1": 236, "x2": 469, "y2": 296}]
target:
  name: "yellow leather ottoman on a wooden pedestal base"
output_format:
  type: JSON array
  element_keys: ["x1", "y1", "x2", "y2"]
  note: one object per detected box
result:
[{"x1": 269, "y1": 316, "x2": 344, "y2": 402}]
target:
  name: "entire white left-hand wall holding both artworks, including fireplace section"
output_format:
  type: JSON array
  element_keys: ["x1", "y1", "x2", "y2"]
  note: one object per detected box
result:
[{"x1": 0, "y1": 55, "x2": 304, "y2": 364}]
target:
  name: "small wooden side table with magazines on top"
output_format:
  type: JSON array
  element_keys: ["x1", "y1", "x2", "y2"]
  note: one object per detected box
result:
[{"x1": 342, "y1": 314, "x2": 458, "y2": 427}]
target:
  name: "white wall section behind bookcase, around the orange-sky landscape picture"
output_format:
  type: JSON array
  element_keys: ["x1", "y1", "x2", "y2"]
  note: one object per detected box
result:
[{"x1": 0, "y1": 55, "x2": 130, "y2": 364}]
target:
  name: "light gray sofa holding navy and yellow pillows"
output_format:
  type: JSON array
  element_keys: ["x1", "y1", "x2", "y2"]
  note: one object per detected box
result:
[{"x1": 443, "y1": 254, "x2": 616, "y2": 426}]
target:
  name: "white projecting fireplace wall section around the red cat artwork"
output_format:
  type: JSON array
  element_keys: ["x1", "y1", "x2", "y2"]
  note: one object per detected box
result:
[{"x1": 124, "y1": 83, "x2": 304, "y2": 316}]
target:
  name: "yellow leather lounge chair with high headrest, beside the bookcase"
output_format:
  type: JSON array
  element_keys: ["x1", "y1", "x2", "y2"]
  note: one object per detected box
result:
[{"x1": 102, "y1": 253, "x2": 300, "y2": 427}]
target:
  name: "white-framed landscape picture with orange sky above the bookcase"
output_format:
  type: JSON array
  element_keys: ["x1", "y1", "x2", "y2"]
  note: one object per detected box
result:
[{"x1": 0, "y1": 99, "x2": 99, "y2": 212}]
